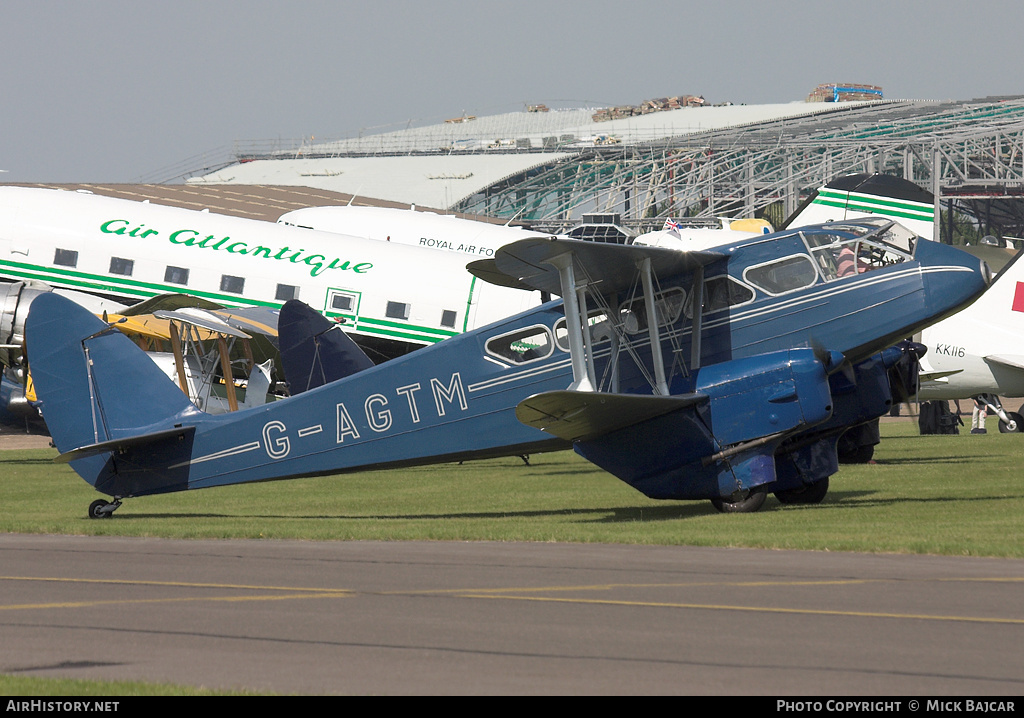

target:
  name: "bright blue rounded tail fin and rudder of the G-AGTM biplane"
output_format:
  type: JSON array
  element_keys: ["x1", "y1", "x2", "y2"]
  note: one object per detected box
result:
[{"x1": 26, "y1": 293, "x2": 200, "y2": 456}]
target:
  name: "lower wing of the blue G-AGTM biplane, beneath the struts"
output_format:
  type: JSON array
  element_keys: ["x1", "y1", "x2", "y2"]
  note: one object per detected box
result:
[{"x1": 515, "y1": 391, "x2": 708, "y2": 441}]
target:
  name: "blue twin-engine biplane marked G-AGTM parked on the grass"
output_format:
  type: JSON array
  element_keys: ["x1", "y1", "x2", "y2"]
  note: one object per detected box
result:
[{"x1": 27, "y1": 219, "x2": 990, "y2": 517}]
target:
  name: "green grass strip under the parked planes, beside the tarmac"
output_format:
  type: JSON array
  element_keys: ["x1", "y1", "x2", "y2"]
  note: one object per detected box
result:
[{"x1": 0, "y1": 422, "x2": 1024, "y2": 557}]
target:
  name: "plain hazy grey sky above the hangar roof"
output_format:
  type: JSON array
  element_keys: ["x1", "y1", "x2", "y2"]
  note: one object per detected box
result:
[{"x1": 0, "y1": 0, "x2": 1024, "y2": 183}]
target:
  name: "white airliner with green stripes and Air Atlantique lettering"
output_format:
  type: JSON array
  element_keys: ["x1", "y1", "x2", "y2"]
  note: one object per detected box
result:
[{"x1": 0, "y1": 186, "x2": 541, "y2": 361}]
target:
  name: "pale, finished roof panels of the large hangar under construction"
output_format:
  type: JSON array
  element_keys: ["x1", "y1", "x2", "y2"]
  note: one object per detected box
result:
[{"x1": 187, "y1": 100, "x2": 890, "y2": 208}]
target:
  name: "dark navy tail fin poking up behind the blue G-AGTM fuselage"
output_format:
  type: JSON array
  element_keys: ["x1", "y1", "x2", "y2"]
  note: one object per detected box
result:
[{"x1": 278, "y1": 299, "x2": 374, "y2": 396}]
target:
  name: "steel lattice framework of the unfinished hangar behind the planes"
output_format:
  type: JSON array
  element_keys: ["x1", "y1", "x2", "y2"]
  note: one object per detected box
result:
[{"x1": 451, "y1": 96, "x2": 1024, "y2": 237}]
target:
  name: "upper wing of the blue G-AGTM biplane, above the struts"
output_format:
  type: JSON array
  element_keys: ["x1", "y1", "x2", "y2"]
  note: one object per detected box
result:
[{"x1": 482, "y1": 239, "x2": 726, "y2": 296}]
